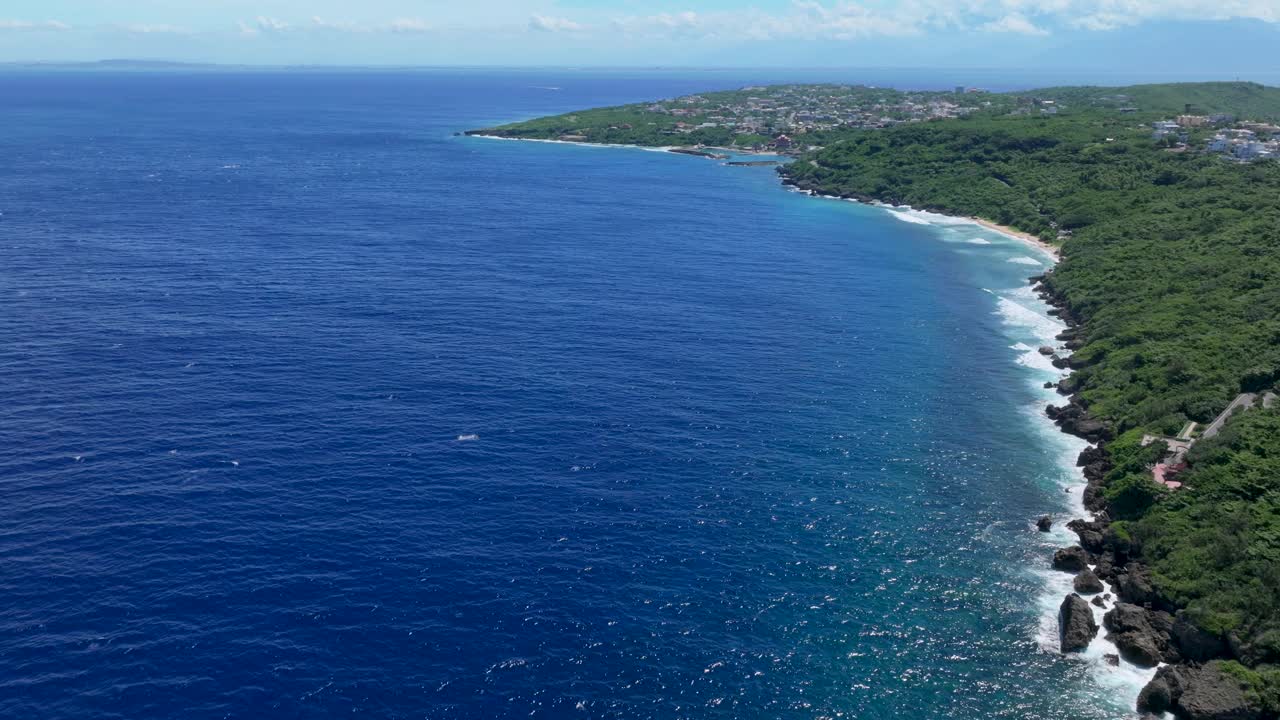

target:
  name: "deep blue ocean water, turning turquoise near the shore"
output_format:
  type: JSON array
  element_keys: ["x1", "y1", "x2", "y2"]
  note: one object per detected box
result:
[{"x1": 0, "y1": 70, "x2": 1132, "y2": 720}]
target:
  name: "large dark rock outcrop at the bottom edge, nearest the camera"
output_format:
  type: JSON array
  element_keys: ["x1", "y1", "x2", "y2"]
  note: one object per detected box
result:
[{"x1": 1138, "y1": 664, "x2": 1263, "y2": 720}]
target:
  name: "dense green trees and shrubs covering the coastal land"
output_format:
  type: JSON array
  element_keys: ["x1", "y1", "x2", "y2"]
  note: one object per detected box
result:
[{"x1": 483, "y1": 83, "x2": 1280, "y2": 696}]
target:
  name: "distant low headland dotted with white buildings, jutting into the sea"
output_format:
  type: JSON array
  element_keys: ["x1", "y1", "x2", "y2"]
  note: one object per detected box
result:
[{"x1": 468, "y1": 82, "x2": 1280, "y2": 150}]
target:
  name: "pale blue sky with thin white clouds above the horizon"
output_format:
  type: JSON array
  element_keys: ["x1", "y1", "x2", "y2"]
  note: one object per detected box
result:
[{"x1": 0, "y1": 0, "x2": 1280, "y2": 69}]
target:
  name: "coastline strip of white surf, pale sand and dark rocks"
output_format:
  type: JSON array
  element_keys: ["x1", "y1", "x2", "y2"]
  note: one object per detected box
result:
[{"x1": 468, "y1": 121, "x2": 1256, "y2": 717}]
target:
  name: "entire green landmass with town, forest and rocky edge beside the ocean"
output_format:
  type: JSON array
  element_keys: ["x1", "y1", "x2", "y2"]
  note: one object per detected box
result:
[{"x1": 470, "y1": 82, "x2": 1280, "y2": 720}]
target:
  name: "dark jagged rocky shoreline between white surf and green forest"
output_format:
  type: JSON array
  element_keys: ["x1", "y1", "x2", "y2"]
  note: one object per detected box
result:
[{"x1": 782, "y1": 172, "x2": 1265, "y2": 720}]
